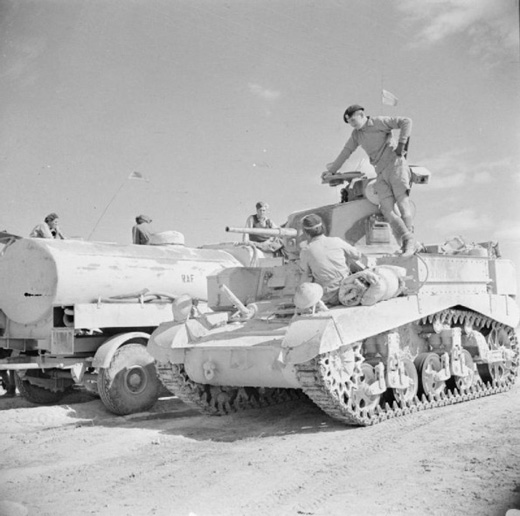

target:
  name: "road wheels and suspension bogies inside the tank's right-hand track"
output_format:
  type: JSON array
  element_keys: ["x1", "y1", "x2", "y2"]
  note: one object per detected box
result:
[{"x1": 352, "y1": 310, "x2": 518, "y2": 418}]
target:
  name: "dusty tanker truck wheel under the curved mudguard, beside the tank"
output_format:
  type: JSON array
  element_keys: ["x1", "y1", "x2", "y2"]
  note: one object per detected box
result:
[{"x1": 98, "y1": 343, "x2": 162, "y2": 416}]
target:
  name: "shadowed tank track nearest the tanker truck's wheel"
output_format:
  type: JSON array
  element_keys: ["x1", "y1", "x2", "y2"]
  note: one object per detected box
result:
[{"x1": 156, "y1": 362, "x2": 303, "y2": 416}]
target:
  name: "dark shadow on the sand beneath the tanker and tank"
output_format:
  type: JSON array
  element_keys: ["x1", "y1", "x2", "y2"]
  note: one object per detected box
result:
[{"x1": 0, "y1": 392, "x2": 355, "y2": 442}]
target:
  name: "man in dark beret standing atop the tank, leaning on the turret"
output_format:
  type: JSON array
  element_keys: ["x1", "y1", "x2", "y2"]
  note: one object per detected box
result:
[{"x1": 323, "y1": 104, "x2": 415, "y2": 256}]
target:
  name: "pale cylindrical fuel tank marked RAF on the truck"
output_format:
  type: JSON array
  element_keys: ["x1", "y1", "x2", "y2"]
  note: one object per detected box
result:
[{"x1": 0, "y1": 238, "x2": 241, "y2": 324}]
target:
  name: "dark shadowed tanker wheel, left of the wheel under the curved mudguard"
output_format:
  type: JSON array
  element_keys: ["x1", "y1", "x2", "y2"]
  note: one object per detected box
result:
[{"x1": 14, "y1": 369, "x2": 72, "y2": 405}]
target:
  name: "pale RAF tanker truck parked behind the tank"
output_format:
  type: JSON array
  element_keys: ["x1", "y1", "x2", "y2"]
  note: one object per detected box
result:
[{"x1": 0, "y1": 232, "x2": 264, "y2": 415}]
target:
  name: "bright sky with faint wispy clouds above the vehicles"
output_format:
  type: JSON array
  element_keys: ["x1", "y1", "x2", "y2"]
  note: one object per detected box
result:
[{"x1": 0, "y1": 0, "x2": 520, "y2": 275}]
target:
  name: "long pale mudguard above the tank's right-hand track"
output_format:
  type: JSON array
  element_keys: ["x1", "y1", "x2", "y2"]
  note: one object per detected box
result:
[{"x1": 280, "y1": 294, "x2": 520, "y2": 364}]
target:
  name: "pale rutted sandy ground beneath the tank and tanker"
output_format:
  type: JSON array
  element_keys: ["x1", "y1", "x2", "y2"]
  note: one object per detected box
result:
[{"x1": 0, "y1": 386, "x2": 520, "y2": 516}]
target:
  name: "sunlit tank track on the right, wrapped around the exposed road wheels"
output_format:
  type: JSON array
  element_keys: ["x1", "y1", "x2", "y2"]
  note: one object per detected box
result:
[{"x1": 296, "y1": 309, "x2": 519, "y2": 426}]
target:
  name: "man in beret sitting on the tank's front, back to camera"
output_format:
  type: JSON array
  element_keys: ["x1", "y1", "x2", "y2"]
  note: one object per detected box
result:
[{"x1": 300, "y1": 213, "x2": 363, "y2": 305}]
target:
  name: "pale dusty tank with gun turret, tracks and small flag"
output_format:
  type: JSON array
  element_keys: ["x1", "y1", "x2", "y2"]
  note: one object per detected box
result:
[{"x1": 148, "y1": 168, "x2": 519, "y2": 426}]
